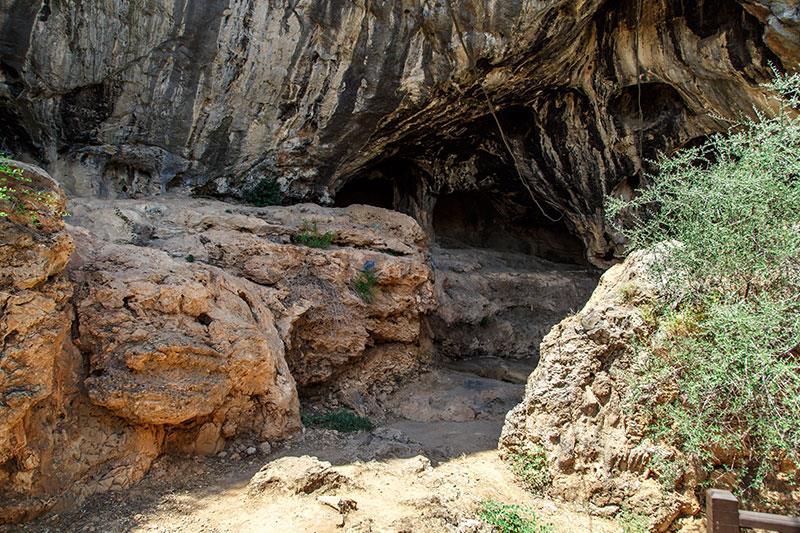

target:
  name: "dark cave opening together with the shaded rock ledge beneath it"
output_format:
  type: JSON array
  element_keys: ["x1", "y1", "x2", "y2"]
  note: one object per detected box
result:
[{"x1": 429, "y1": 191, "x2": 599, "y2": 370}]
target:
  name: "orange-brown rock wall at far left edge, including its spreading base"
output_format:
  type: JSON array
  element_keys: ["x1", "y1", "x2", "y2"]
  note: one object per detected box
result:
[{"x1": 0, "y1": 166, "x2": 163, "y2": 523}]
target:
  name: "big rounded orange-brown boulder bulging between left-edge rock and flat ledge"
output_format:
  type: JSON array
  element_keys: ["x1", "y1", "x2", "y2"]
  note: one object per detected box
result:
[{"x1": 70, "y1": 229, "x2": 299, "y2": 444}]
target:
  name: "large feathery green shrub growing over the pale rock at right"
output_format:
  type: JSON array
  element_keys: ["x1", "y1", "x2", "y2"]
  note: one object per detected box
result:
[{"x1": 608, "y1": 69, "x2": 800, "y2": 495}]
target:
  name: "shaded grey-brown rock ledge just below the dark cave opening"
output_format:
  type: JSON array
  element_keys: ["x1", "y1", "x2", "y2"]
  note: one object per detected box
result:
[{"x1": 430, "y1": 248, "x2": 598, "y2": 366}]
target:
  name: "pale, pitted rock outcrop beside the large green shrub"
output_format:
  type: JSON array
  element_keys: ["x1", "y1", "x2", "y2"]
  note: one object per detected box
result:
[{"x1": 500, "y1": 252, "x2": 699, "y2": 531}]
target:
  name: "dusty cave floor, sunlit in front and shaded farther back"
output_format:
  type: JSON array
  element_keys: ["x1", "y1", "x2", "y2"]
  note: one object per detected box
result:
[{"x1": 19, "y1": 358, "x2": 622, "y2": 533}]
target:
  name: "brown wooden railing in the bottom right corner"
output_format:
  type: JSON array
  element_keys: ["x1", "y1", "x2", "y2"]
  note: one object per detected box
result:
[{"x1": 706, "y1": 489, "x2": 800, "y2": 533}]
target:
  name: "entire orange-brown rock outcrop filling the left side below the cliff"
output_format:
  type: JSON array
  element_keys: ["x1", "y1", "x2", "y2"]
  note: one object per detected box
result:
[{"x1": 0, "y1": 164, "x2": 433, "y2": 522}]
